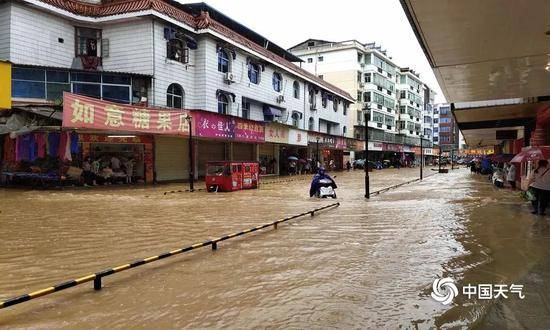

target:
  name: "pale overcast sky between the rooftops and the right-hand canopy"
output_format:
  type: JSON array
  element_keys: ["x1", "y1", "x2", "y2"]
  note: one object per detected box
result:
[{"x1": 179, "y1": 0, "x2": 445, "y2": 103}]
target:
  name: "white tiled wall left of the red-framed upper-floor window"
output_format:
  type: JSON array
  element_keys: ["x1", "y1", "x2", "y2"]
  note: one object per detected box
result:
[{"x1": 9, "y1": 3, "x2": 75, "y2": 67}]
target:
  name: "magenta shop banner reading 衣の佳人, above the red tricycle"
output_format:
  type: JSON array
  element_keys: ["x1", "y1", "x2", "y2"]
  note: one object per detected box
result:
[{"x1": 192, "y1": 111, "x2": 265, "y2": 142}]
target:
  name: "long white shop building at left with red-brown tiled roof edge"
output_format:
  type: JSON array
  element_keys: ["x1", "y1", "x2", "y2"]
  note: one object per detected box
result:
[{"x1": 0, "y1": 0, "x2": 354, "y2": 181}]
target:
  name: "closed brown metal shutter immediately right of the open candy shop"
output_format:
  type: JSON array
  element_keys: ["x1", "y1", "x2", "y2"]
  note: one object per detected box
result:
[{"x1": 155, "y1": 136, "x2": 189, "y2": 182}]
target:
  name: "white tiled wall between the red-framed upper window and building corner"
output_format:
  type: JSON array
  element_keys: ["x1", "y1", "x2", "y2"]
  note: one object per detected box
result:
[{"x1": 102, "y1": 18, "x2": 153, "y2": 75}]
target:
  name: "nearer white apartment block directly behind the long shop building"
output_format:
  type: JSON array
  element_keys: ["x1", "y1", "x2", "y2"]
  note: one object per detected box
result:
[{"x1": 289, "y1": 39, "x2": 397, "y2": 138}]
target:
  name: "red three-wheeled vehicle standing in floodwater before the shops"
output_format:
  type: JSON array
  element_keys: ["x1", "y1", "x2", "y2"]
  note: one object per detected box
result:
[{"x1": 205, "y1": 161, "x2": 260, "y2": 192}]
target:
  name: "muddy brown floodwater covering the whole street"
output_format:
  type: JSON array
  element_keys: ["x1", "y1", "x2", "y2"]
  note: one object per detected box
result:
[{"x1": 0, "y1": 169, "x2": 550, "y2": 329}]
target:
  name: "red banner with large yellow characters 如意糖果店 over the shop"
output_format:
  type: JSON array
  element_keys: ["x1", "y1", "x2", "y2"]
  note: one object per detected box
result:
[{"x1": 63, "y1": 92, "x2": 189, "y2": 135}]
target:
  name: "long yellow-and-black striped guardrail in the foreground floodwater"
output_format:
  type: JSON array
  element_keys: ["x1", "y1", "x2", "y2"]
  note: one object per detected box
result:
[{"x1": 0, "y1": 203, "x2": 340, "y2": 309}]
